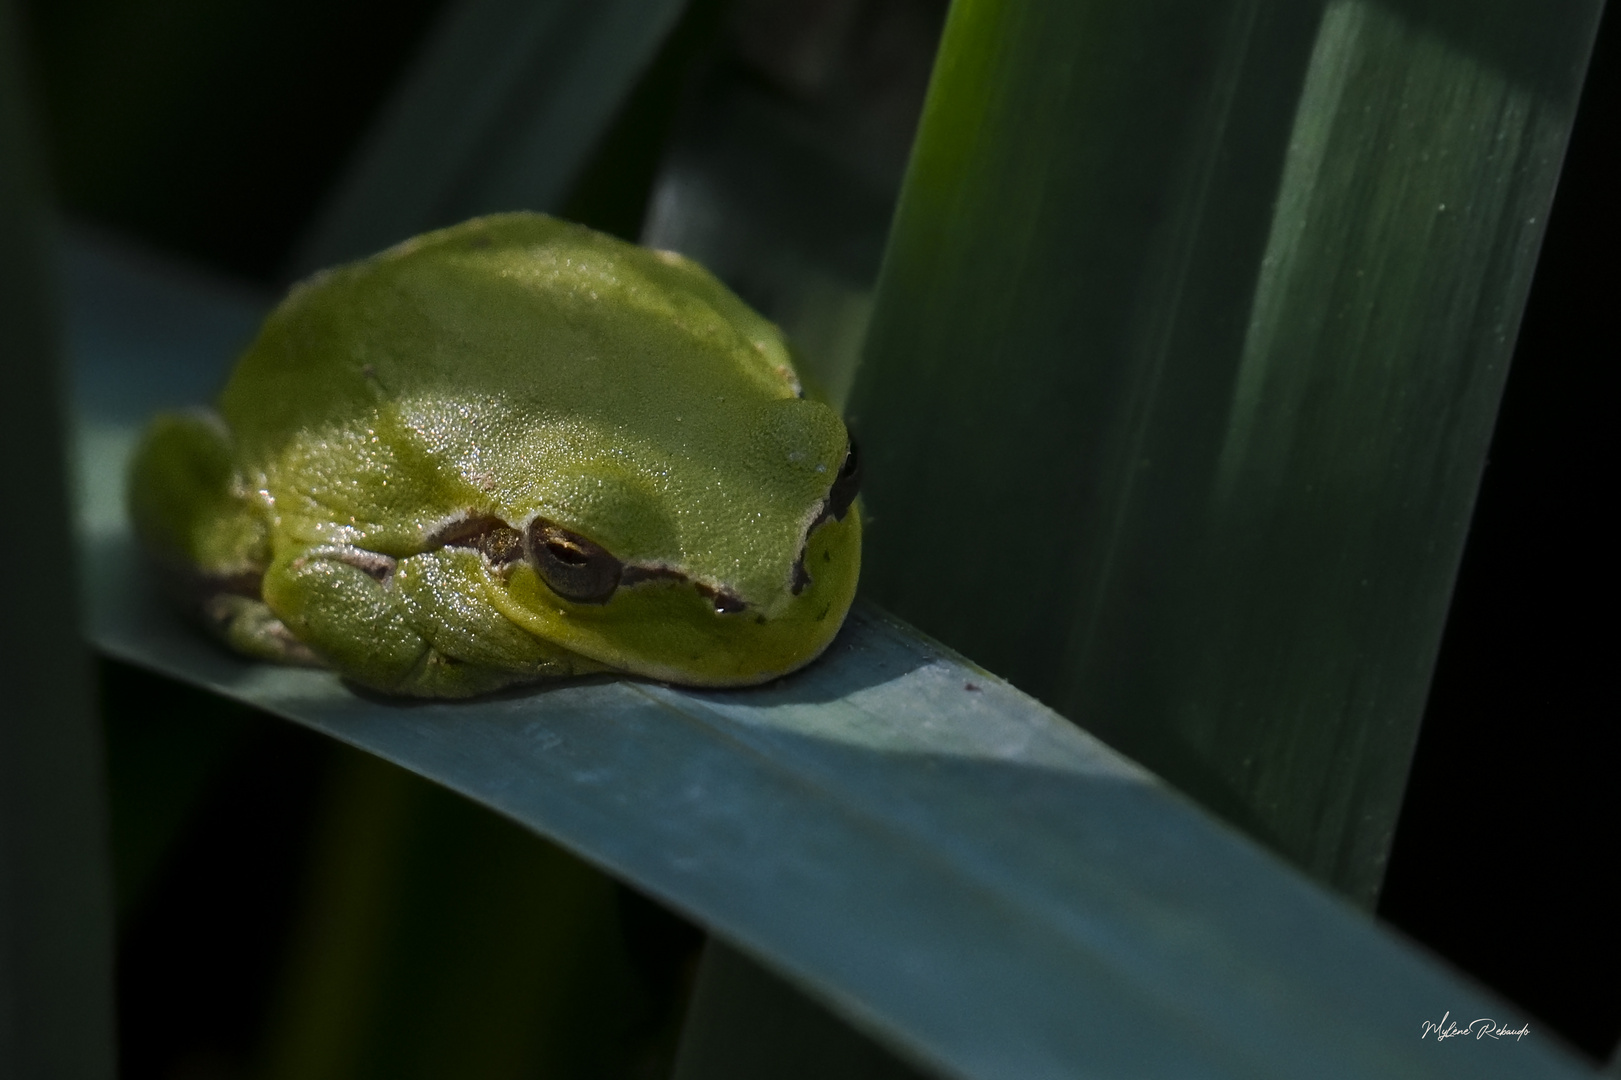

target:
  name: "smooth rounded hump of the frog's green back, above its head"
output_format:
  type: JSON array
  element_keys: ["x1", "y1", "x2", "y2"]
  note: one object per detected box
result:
[{"x1": 220, "y1": 214, "x2": 799, "y2": 464}]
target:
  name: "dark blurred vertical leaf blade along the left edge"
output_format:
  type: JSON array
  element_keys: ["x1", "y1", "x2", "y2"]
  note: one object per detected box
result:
[{"x1": 0, "y1": 0, "x2": 115, "y2": 1080}]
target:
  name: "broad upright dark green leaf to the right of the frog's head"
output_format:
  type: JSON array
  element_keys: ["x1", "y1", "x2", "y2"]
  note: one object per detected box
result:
[{"x1": 851, "y1": 0, "x2": 1600, "y2": 906}]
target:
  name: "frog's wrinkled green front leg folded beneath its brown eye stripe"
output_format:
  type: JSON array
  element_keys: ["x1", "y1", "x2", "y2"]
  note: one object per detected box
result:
[{"x1": 263, "y1": 545, "x2": 601, "y2": 697}]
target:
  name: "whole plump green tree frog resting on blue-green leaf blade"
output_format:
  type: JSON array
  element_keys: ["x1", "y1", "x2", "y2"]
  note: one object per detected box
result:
[{"x1": 130, "y1": 214, "x2": 861, "y2": 697}]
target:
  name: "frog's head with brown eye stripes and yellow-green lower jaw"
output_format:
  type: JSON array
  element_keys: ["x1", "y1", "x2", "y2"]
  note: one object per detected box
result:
[{"x1": 463, "y1": 399, "x2": 861, "y2": 686}]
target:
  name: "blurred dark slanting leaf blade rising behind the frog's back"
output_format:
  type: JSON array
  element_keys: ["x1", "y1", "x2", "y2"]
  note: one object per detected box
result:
[{"x1": 293, "y1": 0, "x2": 686, "y2": 276}]
